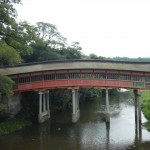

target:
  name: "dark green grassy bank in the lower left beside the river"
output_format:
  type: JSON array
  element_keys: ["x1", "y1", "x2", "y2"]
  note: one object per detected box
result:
[{"x1": 0, "y1": 119, "x2": 31, "y2": 135}]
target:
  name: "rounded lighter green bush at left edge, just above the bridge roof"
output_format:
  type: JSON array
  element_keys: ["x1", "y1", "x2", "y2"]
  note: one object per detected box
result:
[{"x1": 0, "y1": 41, "x2": 21, "y2": 66}]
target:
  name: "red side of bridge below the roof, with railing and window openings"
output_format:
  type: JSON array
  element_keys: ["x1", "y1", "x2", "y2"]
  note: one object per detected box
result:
[{"x1": 11, "y1": 69, "x2": 150, "y2": 91}]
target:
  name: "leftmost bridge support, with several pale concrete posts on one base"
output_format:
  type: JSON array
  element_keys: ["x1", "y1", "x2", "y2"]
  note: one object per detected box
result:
[{"x1": 38, "y1": 91, "x2": 50, "y2": 123}]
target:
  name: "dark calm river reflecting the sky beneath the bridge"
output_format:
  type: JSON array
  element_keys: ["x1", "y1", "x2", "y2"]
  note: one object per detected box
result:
[{"x1": 0, "y1": 92, "x2": 150, "y2": 150}]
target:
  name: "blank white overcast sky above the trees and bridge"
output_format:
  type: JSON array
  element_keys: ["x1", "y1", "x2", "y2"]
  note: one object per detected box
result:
[{"x1": 14, "y1": 0, "x2": 150, "y2": 58}]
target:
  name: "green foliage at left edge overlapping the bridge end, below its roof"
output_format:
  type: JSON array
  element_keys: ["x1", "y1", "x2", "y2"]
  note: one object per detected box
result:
[{"x1": 0, "y1": 75, "x2": 14, "y2": 95}]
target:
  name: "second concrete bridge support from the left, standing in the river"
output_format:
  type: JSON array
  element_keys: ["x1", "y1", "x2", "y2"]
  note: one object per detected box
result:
[{"x1": 72, "y1": 89, "x2": 80, "y2": 123}]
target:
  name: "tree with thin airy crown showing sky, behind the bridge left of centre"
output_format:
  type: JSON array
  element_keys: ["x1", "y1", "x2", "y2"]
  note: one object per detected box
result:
[{"x1": 24, "y1": 22, "x2": 66, "y2": 62}]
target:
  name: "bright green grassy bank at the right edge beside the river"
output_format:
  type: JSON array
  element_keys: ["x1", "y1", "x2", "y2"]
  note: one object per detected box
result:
[{"x1": 141, "y1": 91, "x2": 150, "y2": 131}]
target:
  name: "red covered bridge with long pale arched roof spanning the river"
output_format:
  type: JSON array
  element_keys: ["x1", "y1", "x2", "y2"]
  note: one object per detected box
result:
[{"x1": 0, "y1": 60, "x2": 150, "y2": 124}]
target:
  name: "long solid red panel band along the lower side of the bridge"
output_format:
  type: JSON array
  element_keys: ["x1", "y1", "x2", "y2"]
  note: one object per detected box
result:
[{"x1": 14, "y1": 79, "x2": 133, "y2": 92}]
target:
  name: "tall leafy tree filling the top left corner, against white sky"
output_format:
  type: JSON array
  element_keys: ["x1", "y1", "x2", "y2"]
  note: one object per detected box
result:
[{"x1": 0, "y1": 0, "x2": 34, "y2": 61}]
